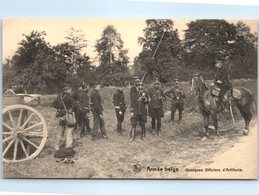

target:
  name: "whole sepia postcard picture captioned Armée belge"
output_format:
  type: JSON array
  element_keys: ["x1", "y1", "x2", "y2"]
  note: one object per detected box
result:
[{"x1": 1, "y1": 18, "x2": 258, "y2": 180}]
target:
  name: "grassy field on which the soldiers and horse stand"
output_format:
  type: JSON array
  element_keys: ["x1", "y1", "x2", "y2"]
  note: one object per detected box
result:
[{"x1": 3, "y1": 80, "x2": 257, "y2": 178}]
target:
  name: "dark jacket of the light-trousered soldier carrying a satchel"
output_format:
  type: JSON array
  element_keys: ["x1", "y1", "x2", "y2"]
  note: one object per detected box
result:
[{"x1": 52, "y1": 93, "x2": 77, "y2": 117}]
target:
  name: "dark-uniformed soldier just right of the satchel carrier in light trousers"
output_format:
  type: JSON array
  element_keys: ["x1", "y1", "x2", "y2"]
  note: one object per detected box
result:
[{"x1": 79, "y1": 82, "x2": 91, "y2": 137}]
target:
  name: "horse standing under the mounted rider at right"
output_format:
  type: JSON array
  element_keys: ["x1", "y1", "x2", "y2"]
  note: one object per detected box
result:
[{"x1": 191, "y1": 76, "x2": 255, "y2": 136}]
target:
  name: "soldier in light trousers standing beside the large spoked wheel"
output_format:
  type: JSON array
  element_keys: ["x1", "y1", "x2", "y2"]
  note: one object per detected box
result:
[{"x1": 52, "y1": 82, "x2": 77, "y2": 150}]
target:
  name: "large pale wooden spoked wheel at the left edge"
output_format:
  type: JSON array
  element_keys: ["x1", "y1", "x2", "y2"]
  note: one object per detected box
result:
[{"x1": 2, "y1": 104, "x2": 48, "y2": 162}]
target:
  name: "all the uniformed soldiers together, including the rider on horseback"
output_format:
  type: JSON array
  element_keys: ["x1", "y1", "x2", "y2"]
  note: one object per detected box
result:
[{"x1": 52, "y1": 59, "x2": 232, "y2": 150}]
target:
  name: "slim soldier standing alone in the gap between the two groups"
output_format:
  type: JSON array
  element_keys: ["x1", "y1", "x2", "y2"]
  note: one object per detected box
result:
[{"x1": 113, "y1": 84, "x2": 126, "y2": 135}]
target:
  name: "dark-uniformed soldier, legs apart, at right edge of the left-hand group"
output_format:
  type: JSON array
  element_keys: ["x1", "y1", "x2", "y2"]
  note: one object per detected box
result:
[{"x1": 90, "y1": 84, "x2": 108, "y2": 141}]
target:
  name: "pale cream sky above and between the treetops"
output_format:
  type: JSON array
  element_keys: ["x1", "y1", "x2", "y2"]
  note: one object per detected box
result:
[{"x1": 2, "y1": 19, "x2": 257, "y2": 64}]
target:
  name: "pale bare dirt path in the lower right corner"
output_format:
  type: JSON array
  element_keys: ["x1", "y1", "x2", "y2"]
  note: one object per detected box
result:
[{"x1": 187, "y1": 121, "x2": 257, "y2": 179}]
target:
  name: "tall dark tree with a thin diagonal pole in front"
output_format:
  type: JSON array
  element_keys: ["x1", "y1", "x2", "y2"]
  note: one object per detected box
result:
[{"x1": 134, "y1": 20, "x2": 182, "y2": 82}]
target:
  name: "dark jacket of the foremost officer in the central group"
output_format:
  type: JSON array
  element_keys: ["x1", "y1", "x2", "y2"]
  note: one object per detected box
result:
[{"x1": 130, "y1": 90, "x2": 149, "y2": 114}]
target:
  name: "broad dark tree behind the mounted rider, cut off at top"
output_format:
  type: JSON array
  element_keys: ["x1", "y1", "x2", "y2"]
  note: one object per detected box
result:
[{"x1": 183, "y1": 20, "x2": 236, "y2": 74}]
